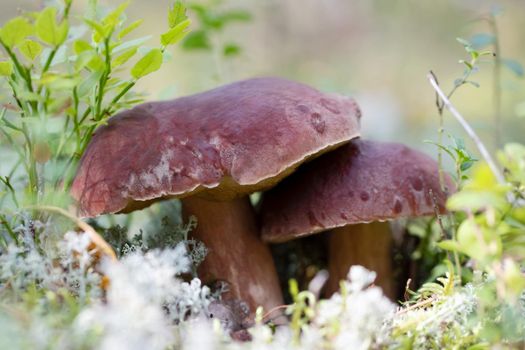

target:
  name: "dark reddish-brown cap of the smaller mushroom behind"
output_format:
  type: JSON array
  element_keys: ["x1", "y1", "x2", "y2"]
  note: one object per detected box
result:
[{"x1": 261, "y1": 139, "x2": 453, "y2": 242}]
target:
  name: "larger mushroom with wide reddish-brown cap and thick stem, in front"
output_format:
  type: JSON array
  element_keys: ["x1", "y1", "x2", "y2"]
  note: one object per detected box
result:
[{"x1": 72, "y1": 78, "x2": 360, "y2": 310}]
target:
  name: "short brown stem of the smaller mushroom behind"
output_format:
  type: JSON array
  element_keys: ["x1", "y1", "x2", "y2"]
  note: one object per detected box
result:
[{"x1": 325, "y1": 222, "x2": 394, "y2": 299}]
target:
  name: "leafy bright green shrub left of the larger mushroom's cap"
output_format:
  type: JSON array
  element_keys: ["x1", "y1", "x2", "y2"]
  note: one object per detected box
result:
[{"x1": 0, "y1": 0, "x2": 190, "y2": 215}]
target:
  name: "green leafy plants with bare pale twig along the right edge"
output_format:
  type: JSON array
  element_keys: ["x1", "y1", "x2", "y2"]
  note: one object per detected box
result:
[{"x1": 422, "y1": 21, "x2": 525, "y2": 345}]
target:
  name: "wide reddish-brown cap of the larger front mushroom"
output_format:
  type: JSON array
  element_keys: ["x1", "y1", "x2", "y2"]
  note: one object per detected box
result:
[{"x1": 72, "y1": 78, "x2": 360, "y2": 216}]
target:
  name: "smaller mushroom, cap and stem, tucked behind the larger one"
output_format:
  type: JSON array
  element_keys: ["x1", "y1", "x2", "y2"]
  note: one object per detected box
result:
[{"x1": 261, "y1": 139, "x2": 450, "y2": 297}]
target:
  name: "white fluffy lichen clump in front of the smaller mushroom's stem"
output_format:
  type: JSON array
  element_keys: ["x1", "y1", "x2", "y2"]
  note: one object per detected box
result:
[{"x1": 174, "y1": 266, "x2": 396, "y2": 350}]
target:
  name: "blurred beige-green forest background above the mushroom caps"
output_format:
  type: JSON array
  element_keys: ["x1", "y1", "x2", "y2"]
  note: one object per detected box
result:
[{"x1": 0, "y1": 0, "x2": 525, "y2": 154}]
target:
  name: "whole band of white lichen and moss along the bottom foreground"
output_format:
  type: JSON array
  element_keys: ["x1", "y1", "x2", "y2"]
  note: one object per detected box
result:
[{"x1": 0, "y1": 227, "x2": 523, "y2": 350}]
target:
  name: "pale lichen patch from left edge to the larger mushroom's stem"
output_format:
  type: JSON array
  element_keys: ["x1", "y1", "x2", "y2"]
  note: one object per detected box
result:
[{"x1": 0, "y1": 228, "x2": 211, "y2": 349}]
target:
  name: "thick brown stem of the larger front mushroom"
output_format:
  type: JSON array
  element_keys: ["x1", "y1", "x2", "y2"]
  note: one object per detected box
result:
[{"x1": 182, "y1": 196, "x2": 284, "y2": 314}]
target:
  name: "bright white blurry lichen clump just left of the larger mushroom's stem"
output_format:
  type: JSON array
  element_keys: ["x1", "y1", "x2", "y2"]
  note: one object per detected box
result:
[{"x1": 75, "y1": 243, "x2": 211, "y2": 349}]
